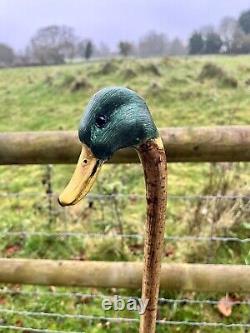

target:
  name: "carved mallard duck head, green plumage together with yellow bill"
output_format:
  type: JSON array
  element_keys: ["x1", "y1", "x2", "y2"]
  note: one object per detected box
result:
[{"x1": 59, "y1": 87, "x2": 158, "y2": 206}]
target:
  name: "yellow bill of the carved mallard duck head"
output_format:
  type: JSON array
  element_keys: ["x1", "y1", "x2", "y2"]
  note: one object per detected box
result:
[{"x1": 58, "y1": 145, "x2": 103, "y2": 206}]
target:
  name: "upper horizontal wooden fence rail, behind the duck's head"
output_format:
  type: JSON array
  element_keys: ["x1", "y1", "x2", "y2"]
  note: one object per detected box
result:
[{"x1": 0, "y1": 126, "x2": 250, "y2": 164}]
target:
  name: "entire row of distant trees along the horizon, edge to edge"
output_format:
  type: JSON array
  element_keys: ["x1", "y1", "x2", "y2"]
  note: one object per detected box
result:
[{"x1": 0, "y1": 10, "x2": 250, "y2": 67}]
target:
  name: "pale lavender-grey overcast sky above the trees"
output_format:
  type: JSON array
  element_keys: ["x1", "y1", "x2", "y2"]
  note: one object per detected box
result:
[{"x1": 0, "y1": 0, "x2": 250, "y2": 50}]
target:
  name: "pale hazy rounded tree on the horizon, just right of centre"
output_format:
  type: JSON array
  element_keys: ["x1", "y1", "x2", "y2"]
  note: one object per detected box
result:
[{"x1": 138, "y1": 31, "x2": 169, "y2": 57}]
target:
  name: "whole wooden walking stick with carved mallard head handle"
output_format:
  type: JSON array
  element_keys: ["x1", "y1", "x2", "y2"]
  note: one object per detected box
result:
[{"x1": 59, "y1": 87, "x2": 166, "y2": 333}]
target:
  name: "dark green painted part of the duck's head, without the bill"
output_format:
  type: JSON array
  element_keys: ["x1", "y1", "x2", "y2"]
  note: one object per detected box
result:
[{"x1": 79, "y1": 87, "x2": 157, "y2": 161}]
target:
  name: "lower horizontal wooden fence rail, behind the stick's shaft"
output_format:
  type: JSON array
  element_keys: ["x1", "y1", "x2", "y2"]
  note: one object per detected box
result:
[{"x1": 0, "y1": 259, "x2": 250, "y2": 292}]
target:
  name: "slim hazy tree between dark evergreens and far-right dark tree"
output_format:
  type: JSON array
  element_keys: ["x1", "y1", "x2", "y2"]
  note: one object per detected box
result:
[{"x1": 219, "y1": 17, "x2": 238, "y2": 53}]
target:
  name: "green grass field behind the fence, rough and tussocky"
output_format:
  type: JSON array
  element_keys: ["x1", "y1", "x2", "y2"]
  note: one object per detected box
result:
[{"x1": 0, "y1": 56, "x2": 250, "y2": 333}]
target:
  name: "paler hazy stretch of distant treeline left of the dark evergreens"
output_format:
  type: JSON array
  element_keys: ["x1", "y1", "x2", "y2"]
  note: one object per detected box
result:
[{"x1": 0, "y1": 25, "x2": 187, "y2": 67}]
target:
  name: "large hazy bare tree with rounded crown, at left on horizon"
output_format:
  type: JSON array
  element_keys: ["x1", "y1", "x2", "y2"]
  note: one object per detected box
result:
[{"x1": 30, "y1": 25, "x2": 76, "y2": 65}]
